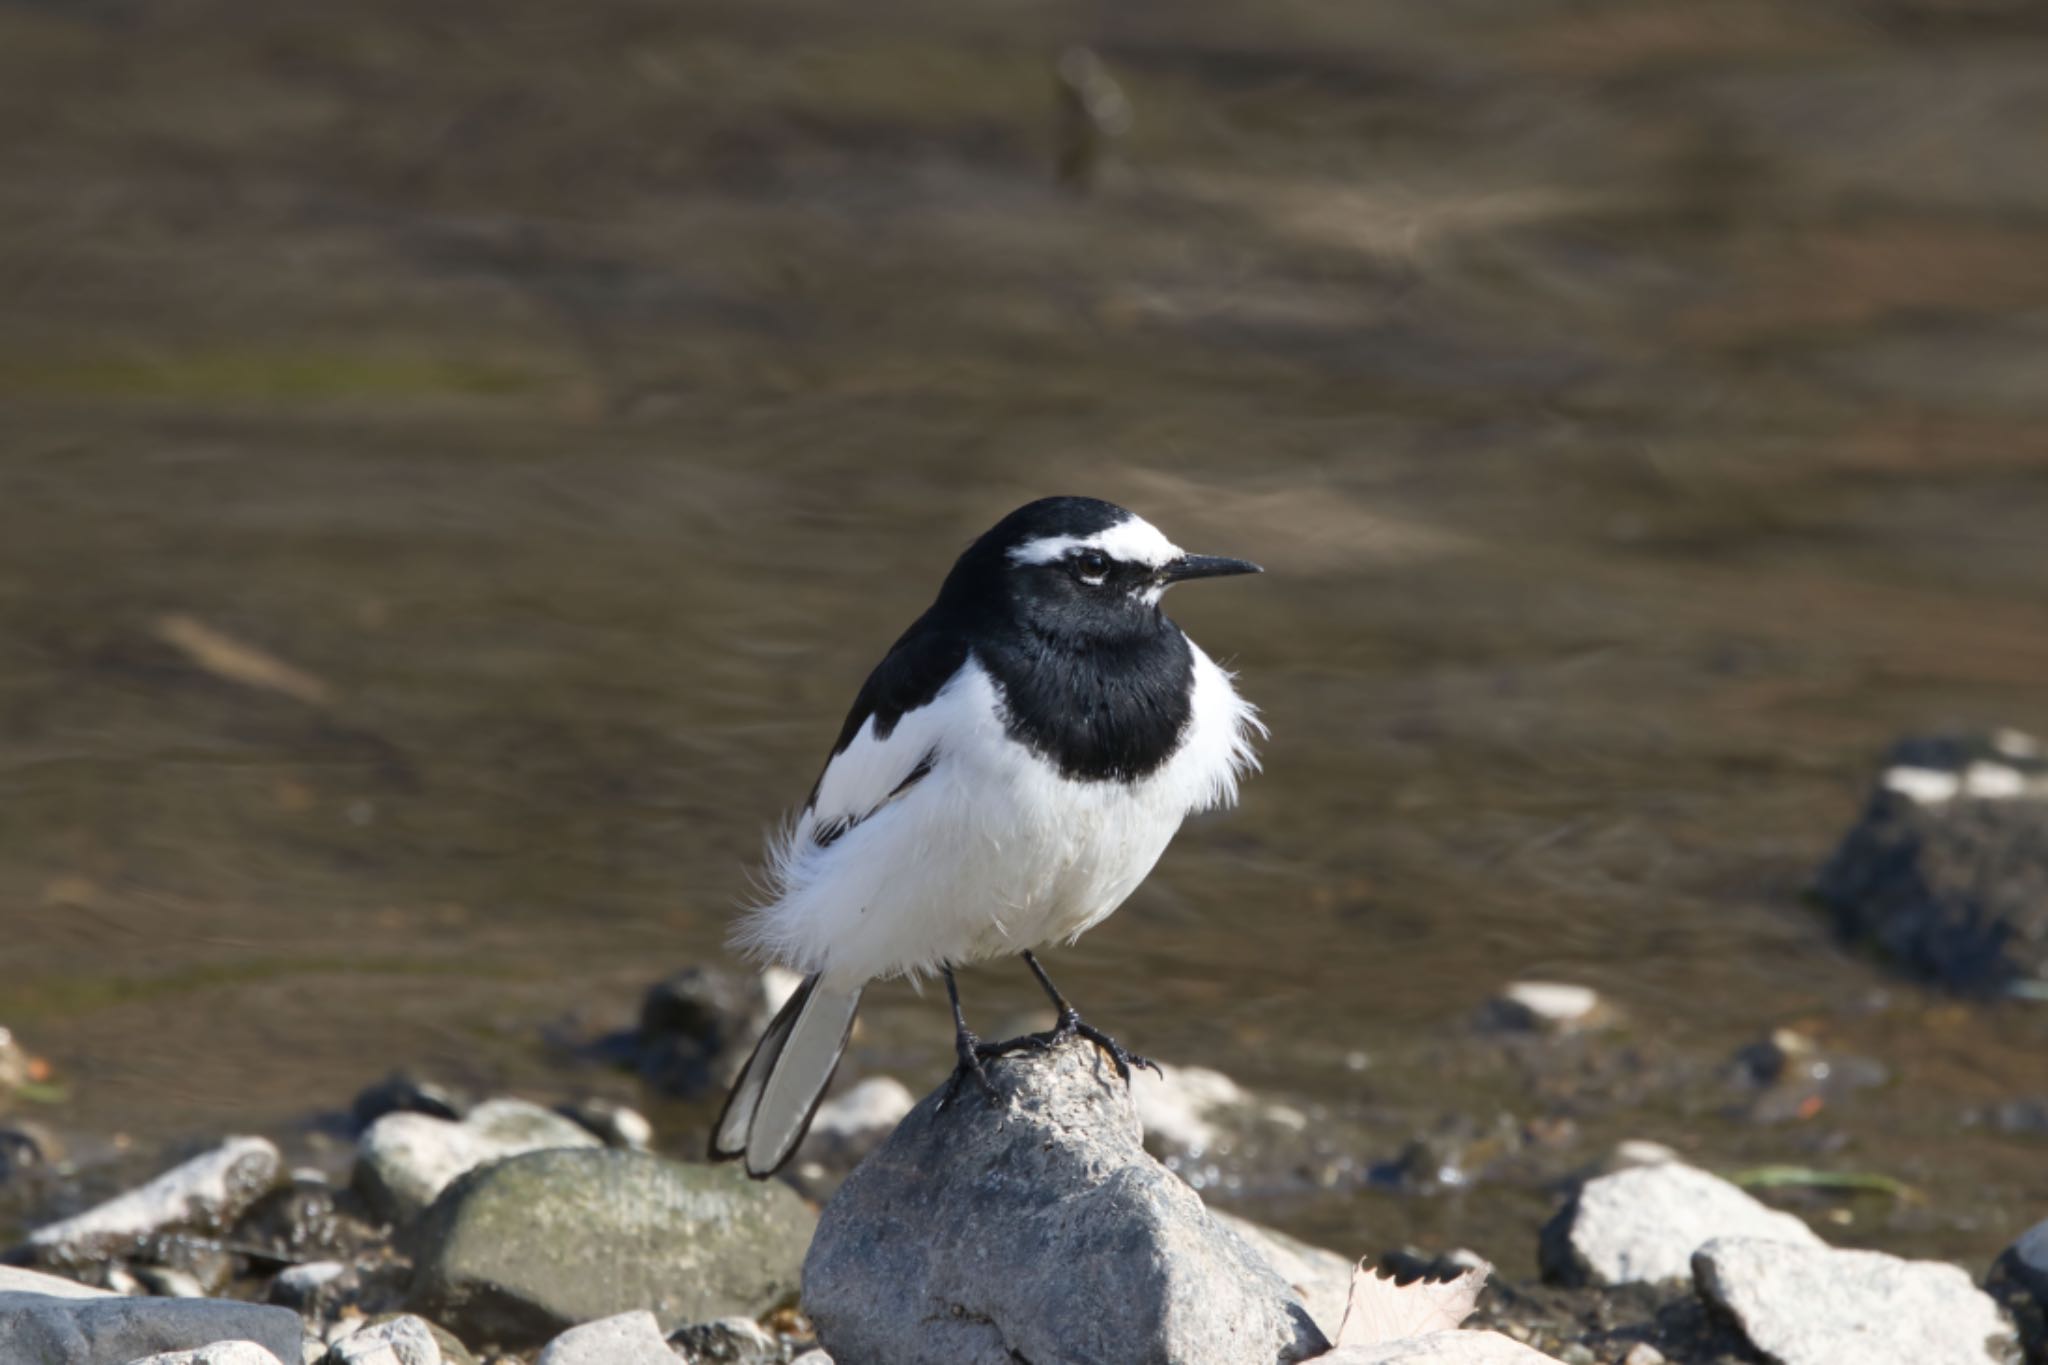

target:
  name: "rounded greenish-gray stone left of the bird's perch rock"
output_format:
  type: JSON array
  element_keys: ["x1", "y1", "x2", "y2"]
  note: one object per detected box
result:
[{"x1": 412, "y1": 1148, "x2": 817, "y2": 1347}]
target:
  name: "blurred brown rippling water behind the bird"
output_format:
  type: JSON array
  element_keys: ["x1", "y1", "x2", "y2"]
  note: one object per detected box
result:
[{"x1": 0, "y1": 0, "x2": 2048, "y2": 1259}]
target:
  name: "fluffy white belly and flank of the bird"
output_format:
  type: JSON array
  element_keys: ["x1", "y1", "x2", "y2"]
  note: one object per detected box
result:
[{"x1": 741, "y1": 649, "x2": 1257, "y2": 982}]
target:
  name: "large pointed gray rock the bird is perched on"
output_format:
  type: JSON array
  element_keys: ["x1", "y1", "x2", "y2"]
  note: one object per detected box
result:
[{"x1": 803, "y1": 1040, "x2": 1327, "y2": 1365}]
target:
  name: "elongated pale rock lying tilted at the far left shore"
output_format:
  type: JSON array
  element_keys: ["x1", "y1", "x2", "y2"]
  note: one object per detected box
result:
[{"x1": 29, "y1": 1138, "x2": 283, "y2": 1265}]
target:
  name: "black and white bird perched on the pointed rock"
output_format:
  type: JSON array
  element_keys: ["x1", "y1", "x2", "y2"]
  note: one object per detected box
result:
[{"x1": 711, "y1": 497, "x2": 1266, "y2": 1177}]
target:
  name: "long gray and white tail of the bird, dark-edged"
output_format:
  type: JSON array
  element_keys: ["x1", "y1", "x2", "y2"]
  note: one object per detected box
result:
[{"x1": 711, "y1": 974, "x2": 860, "y2": 1181}]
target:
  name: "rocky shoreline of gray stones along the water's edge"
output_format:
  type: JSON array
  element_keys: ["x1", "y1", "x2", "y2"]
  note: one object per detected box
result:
[{"x1": 0, "y1": 737, "x2": 2048, "y2": 1365}]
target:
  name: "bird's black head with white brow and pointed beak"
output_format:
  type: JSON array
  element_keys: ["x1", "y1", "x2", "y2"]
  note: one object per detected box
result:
[{"x1": 942, "y1": 497, "x2": 1262, "y2": 639}]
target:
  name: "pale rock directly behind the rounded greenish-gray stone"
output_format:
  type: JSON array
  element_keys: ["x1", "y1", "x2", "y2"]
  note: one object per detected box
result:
[{"x1": 352, "y1": 1099, "x2": 602, "y2": 1224}]
